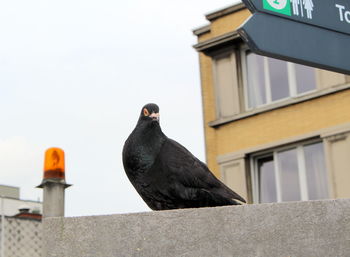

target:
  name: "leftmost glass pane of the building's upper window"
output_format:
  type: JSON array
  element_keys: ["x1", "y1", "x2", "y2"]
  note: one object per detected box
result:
[{"x1": 247, "y1": 53, "x2": 266, "y2": 108}]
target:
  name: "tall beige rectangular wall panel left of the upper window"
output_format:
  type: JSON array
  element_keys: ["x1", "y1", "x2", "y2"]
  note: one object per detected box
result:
[{"x1": 213, "y1": 50, "x2": 240, "y2": 118}]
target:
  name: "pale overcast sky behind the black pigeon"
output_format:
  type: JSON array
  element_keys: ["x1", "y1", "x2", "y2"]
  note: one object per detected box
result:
[{"x1": 0, "y1": 0, "x2": 238, "y2": 216}]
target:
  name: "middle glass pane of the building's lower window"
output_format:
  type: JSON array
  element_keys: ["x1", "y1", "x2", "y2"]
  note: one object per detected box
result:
[{"x1": 277, "y1": 148, "x2": 301, "y2": 201}]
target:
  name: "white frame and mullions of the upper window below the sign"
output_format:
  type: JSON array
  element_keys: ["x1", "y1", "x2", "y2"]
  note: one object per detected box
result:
[{"x1": 240, "y1": 46, "x2": 317, "y2": 111}]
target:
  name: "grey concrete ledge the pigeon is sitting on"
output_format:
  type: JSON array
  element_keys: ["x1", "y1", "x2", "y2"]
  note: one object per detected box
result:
[{"x1": 44, "y1": 199, "x2": 350, "y2": 257}]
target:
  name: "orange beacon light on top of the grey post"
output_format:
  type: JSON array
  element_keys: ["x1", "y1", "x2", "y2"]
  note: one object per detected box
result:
[{"x1": 44, "y1": 147, "x2": 65, "y2": 180}]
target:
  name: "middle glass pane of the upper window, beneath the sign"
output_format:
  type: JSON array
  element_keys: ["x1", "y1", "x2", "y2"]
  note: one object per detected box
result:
[{"x1": 268, "y1": 58, "x2": 289, "y2": 101}]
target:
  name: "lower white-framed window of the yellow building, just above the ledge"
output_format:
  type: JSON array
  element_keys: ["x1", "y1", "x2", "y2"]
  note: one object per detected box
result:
[{"x1": 252, "y1": 142, "x2": 328, "y2": 203}]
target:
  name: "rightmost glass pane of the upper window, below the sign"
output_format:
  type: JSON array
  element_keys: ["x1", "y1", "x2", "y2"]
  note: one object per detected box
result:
[{"x1": 294, "y1": 64, "x2": 316, "y2": 94}]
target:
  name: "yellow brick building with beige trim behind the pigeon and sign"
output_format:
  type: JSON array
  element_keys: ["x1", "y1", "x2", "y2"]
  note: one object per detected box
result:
[{"x1": 193, "y1": 4, "x2": 350, "y2": 203}]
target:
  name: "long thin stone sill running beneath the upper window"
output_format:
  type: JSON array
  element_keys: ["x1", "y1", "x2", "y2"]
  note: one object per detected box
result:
[{"x1": 208, "y1": 84, "x2": 350, "y2": 128}]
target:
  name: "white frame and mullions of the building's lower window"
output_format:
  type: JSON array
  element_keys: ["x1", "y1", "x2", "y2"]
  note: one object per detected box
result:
[{"x1": 250, "y1": 139, "x2": 329, "y2": 203}]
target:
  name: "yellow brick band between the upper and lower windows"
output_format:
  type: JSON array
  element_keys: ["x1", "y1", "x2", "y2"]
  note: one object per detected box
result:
[{"x1": 216, "y1": 90, "x2": 350, "y2": 155}]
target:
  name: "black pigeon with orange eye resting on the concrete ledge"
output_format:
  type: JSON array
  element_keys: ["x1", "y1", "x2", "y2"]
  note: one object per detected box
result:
[{"x1": 123, "y1": 104, "x2": 245, "y2": 210}]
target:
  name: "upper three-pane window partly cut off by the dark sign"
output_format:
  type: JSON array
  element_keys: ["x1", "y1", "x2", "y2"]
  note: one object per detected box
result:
[{"x1": 243, "y1": 51, "x2": 316, "y2": 109}]
